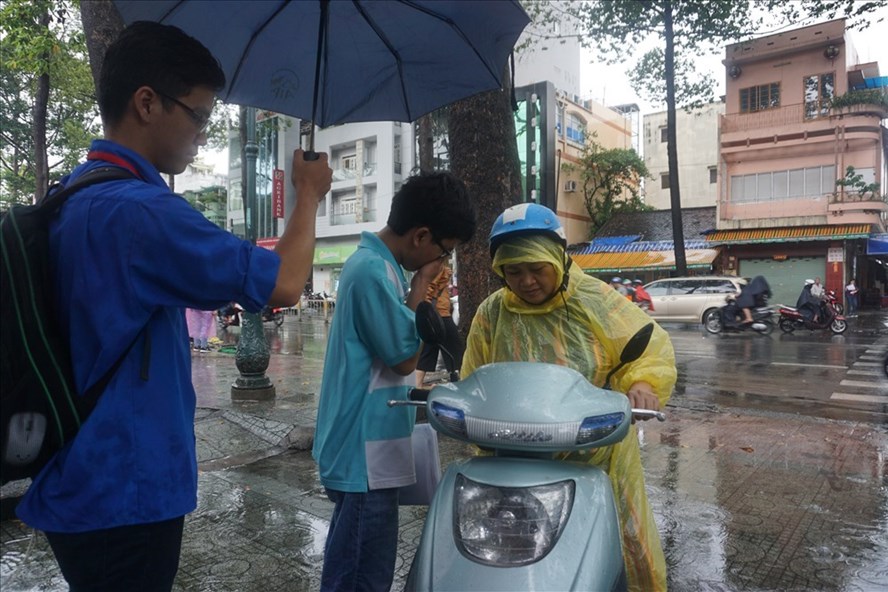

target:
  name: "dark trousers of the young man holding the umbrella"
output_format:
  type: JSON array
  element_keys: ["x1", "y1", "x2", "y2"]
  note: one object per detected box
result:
[{"x1": 46, "y1": 516, "x2": 185, "y2": 592}]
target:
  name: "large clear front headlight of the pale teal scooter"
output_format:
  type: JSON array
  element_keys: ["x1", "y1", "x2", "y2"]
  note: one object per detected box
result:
[{"x1": 453, "y1": 475, "x2": 576, "y2": 567}]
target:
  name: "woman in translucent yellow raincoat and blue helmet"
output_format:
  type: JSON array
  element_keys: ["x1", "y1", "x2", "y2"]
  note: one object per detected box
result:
[{"x1": 462, "y1": 204, "x2": 676, "y2": 592}]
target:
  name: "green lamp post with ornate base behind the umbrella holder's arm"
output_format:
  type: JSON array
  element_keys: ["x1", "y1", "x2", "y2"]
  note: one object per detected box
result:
[{"x1": 231, "y1": 107, "x2": 275, "y2": 401}]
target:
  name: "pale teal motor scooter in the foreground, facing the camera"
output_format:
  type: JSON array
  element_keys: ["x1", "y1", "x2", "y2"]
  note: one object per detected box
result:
[{"x1": 389, "y1": 303, "x2": 665, "y2": 591}]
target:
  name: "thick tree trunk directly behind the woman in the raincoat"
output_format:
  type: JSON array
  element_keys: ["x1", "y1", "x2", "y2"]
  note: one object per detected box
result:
[{"x1": 450, "y1": 74, "x2": 521, "y2": 339}]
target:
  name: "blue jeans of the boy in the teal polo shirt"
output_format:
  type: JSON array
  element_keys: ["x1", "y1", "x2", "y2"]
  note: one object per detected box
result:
[{"x1": 321, "y1": 489, "x2": 398, "y2": 592}]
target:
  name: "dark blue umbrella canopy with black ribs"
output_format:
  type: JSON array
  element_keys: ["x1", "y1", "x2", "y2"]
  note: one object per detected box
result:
[{"x1": 115, "y1": 0, "x2": 529, "y2": 127}]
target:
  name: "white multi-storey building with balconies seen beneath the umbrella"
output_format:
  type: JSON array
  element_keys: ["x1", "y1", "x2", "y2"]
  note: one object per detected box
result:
[{"x1": 228, "y1": 113, "x2": 414, "y2": 295}]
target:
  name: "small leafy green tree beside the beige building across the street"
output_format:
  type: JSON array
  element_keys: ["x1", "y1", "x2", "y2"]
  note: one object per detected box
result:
[{"x1": 562, "y1": 134, "x2": 653, "y2": 237}]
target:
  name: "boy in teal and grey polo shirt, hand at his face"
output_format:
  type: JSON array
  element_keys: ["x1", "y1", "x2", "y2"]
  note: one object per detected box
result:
[{"x1": 312, "y1": 173, "x2": 475, "y2": 591}]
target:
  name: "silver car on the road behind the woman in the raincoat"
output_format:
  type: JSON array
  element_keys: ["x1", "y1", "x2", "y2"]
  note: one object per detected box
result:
[{"x1": 644, "y1": 276, "x2": 746, "y2": 323}]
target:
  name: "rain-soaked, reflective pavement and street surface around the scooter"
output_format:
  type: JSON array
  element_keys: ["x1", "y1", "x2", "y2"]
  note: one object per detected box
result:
[{"x1": 0, "y1": 314, "x2": 888, "y2": 592}]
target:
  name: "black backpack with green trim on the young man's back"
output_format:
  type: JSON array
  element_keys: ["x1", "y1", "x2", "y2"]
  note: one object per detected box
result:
[{"x1": 0, "y1": 166, "x2": 139, "y2": 483}]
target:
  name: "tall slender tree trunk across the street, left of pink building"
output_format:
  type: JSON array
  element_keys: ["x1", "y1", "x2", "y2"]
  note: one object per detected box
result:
[{"x1": 663, "y1": 2, "x2": 688, "y2": 277}]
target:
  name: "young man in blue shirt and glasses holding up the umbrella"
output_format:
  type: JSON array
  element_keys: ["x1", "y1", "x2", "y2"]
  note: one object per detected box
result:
[{"x1": 16, "y1": 22, "x2": 333, "y2": 592}]
